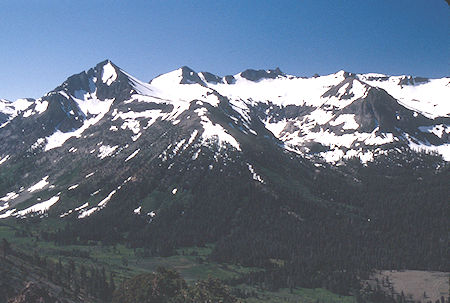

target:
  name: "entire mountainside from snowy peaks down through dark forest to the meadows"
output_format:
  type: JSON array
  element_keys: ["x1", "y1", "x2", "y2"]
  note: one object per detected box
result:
[{"x1": 0, "y1": 60, "x2": 450, "y2": 302}]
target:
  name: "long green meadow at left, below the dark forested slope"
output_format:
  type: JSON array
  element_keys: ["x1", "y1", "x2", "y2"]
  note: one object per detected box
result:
[{"x1": 0, "y1": 220, "x2": 260, "y2": 282}]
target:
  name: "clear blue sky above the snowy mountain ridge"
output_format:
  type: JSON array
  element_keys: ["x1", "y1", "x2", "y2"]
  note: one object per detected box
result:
[{"x1": 0, "y1": 0, "x2": 450, "y2": 100}]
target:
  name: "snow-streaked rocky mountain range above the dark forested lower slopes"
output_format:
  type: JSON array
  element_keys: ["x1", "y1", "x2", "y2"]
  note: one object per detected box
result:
[{"x1": 0, "y1": 60, "x2": 450, "y2": 218}]
